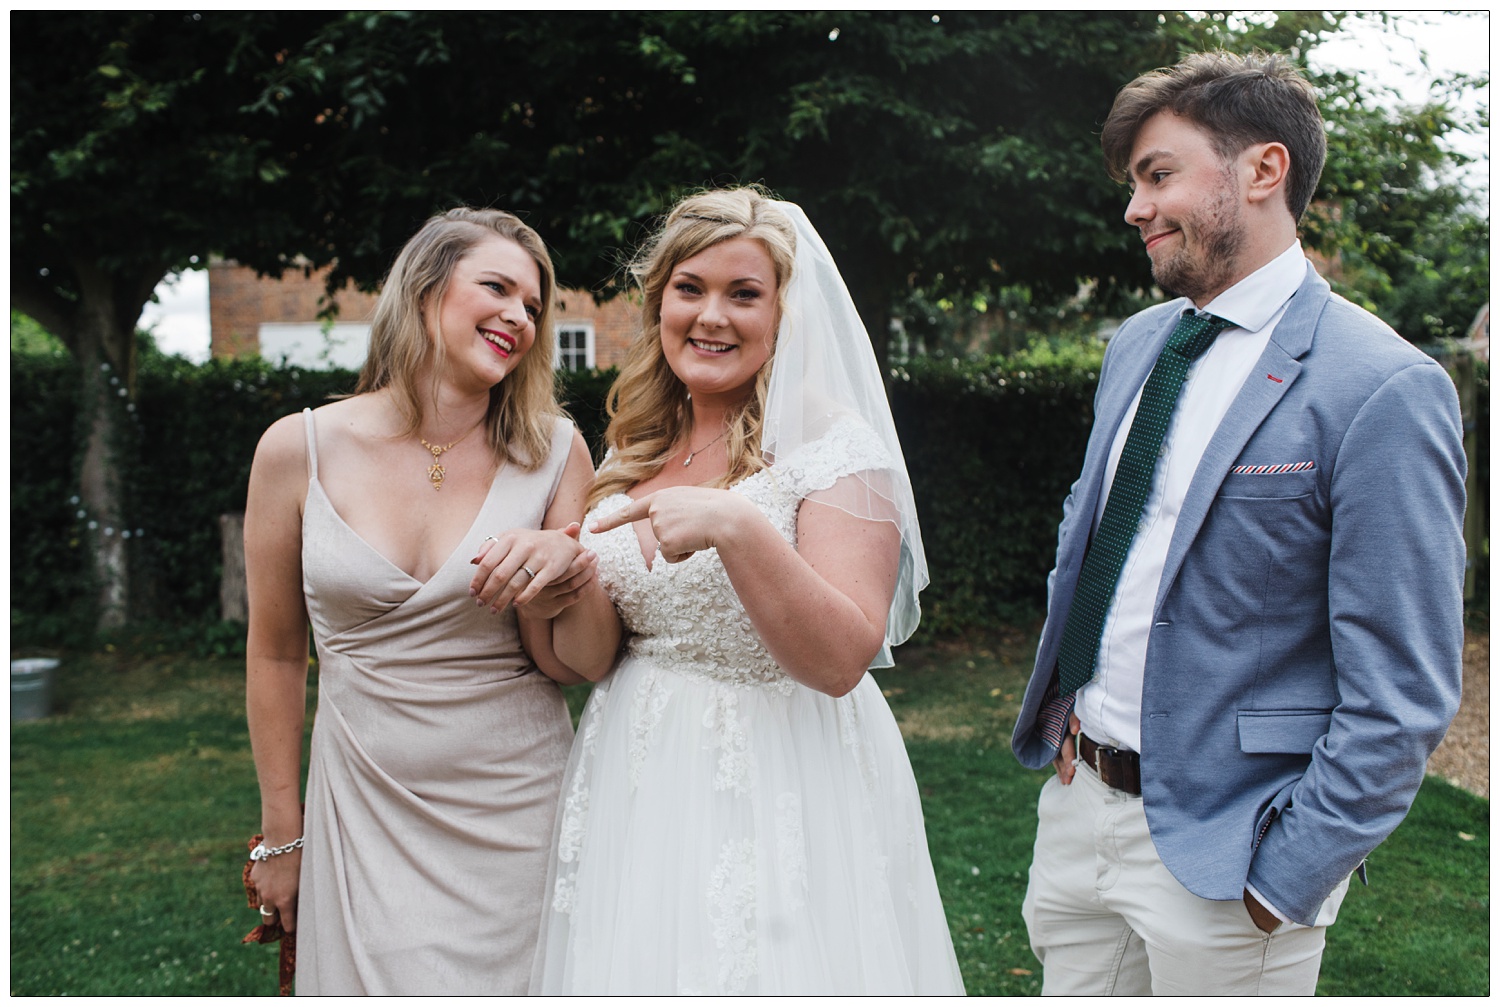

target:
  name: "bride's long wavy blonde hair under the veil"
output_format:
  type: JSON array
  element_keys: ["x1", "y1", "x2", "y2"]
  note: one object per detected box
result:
[{"x1": 588, "y1": 186, "x2": 797, "y2": 507}]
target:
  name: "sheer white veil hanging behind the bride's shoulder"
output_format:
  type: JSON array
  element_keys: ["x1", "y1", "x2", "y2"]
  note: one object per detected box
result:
[{"x1": 761, "y1": 201, "x2": 929, "y2": 668}]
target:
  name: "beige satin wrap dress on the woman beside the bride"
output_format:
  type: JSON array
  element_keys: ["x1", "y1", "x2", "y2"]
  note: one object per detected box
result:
[{"x1": 297, "y1": 411, "x2": 573, "y2": 995}]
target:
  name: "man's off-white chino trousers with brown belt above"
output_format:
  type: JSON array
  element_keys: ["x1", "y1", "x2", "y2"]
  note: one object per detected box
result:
[{"x1": 1022, "y1": 762, "x2": 1349, "y2": 996}]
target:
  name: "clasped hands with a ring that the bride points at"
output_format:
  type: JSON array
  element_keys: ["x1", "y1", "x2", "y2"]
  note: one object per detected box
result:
[{"x1": 470, "y1": 522, "x2": 599, "y2": 618}]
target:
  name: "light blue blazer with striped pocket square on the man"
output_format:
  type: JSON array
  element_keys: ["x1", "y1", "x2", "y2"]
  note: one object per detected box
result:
[{"x1": 1011, "y1": 264, "x2": 1466, "y2": 924}]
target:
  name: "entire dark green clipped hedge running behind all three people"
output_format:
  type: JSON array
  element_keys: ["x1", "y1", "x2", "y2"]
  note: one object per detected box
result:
[{"x1": 11, "y1": 345, "x2": 1490, "y2": 644}]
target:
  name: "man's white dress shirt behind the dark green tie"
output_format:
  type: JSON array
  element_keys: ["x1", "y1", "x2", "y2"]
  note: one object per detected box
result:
[{"x1": 1074, "y1": 242, "x2": 1307, "y2": 752}]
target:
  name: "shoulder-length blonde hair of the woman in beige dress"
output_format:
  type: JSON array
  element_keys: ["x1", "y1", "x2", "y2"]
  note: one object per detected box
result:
[{"x1": 354, "y1": 207, "x2": 563, "y2": 470}]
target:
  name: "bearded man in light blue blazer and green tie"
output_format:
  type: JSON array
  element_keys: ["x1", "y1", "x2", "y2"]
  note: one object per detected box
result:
[{"x1": 1013, "y1": 53, "x2": 1464, "y2": 995}]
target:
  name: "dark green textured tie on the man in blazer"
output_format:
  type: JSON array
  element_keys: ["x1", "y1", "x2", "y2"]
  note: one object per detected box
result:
[{"x1": 1058, "y1": 314, "x2": 1233, "y2": 696}]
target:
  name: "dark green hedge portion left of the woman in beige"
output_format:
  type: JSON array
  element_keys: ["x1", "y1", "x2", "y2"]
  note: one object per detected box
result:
[{"x1": 11, "y1": 351, "x2": 354, "y2": 644}]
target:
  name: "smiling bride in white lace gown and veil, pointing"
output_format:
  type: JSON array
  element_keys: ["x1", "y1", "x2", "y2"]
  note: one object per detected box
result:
[{"x1": 533, "y1": 188, "x2": 963, "y2": 993}]
